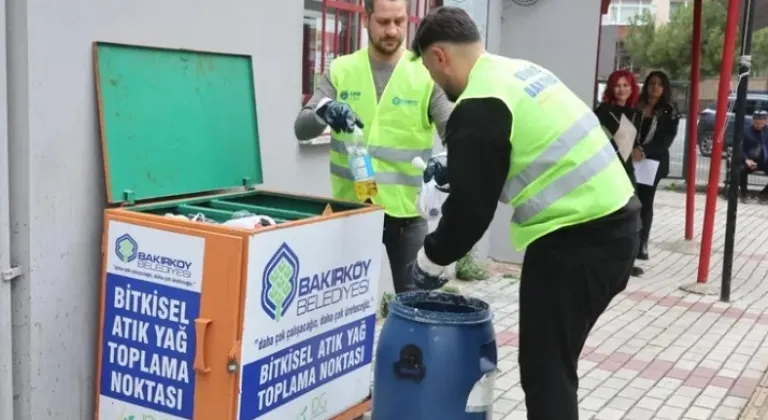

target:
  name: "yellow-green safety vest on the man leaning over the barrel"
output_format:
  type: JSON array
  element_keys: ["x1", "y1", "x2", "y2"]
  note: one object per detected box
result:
[{"x1": 457, "y1": 54, "x2": 634, "y2": 250}]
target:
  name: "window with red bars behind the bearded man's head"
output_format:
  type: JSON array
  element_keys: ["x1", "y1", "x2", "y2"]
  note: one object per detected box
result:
[{"x1": 301, "y1": 0, "x2": 439, "y2": 103}]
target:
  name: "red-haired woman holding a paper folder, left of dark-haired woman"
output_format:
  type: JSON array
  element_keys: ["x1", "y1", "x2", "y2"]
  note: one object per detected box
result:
[{"x1": 595, "y1": 70, "x2": 643, "y2": 277}]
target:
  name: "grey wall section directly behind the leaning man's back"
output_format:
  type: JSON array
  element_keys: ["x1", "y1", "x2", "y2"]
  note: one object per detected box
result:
[{"x1": 489, "y1": 0, "x2": 600, "y2": 262}]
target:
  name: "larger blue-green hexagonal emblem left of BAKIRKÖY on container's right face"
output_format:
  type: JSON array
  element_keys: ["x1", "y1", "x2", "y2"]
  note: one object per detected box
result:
[{"x1": 261, "y1": 242, "x2": 299, "y2": 321}]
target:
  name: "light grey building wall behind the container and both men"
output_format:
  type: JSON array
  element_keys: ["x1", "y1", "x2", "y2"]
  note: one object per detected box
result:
[{"x1": 0, "y1": 0, "x2": 599, "y2": 420}]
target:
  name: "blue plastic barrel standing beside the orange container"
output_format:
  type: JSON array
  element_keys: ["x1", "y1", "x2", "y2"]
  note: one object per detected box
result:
[{"x1": 371, "y1": 291, "x2": 497, "y2": 420}]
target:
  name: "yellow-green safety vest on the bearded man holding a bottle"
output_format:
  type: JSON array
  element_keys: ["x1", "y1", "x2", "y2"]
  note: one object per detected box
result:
[{"x1": 330, "y1": 48, "x2": 435, "y2": 217}]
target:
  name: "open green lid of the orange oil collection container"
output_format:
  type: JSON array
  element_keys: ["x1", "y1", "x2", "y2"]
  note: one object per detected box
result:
[{"x1": 94, "y1": 42, "x2": 263, "y2": 203}]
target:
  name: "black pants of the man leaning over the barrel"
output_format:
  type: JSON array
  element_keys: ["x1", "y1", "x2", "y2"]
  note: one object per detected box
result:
[{"x1": 519, "y1": 230, "x2": 639, "y2": 420}]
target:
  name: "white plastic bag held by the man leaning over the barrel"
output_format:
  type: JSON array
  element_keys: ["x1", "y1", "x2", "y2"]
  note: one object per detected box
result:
[{"x1": 411, "y1": 152, "x2": 450, "y2": 220}]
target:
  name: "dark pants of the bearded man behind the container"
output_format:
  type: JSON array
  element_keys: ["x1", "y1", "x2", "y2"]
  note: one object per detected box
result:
[{"x1": 383, "y1": 215, "x2": 429, "y2": 293}]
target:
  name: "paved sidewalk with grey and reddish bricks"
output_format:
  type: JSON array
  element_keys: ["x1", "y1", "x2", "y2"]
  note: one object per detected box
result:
[{"x1": 404, "y1": 191, "x2": 768, "y2": 420}]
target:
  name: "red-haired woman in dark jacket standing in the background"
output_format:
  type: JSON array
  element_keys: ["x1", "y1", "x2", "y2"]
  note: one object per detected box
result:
[{"x1": 595, "y1": 70, "x2": 643, "y2": 277}]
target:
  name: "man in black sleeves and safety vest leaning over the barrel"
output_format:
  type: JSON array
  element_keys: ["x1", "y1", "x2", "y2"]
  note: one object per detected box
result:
[{"x1": 413, "y1": 7, "x2": 640, "y2": 420}]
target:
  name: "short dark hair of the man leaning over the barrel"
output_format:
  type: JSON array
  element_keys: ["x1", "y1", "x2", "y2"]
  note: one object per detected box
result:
[{"x1": 411, "y1": 6, "x2": 481, "y2": 58}]
